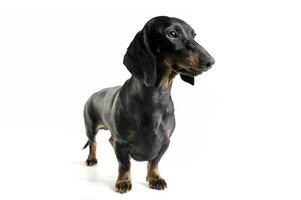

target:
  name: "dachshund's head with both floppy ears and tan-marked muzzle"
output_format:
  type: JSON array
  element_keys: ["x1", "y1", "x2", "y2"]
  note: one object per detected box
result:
[{"x1": 123, "y1": 16, "x2": 215, "y2": 86}]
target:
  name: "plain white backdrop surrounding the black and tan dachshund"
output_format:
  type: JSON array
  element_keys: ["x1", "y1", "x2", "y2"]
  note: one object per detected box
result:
[{"x1": 0, "y1": 0, "x2": 301, "y2": 200}]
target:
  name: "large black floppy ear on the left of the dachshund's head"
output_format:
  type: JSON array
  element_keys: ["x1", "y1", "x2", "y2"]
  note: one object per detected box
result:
[{"x1": 123, "y1": 24, "x2": 157, "y2": 87}]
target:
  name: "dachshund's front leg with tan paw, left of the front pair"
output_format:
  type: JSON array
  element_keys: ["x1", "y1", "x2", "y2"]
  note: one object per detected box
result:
[{"x1": 114, "y1": 142, "x2": 132, "y2": 193}]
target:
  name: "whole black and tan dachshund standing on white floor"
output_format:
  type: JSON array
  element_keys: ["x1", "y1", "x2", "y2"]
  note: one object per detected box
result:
[{"x1": 84, "y1": 16, "x2": 215, "y2": 193}]
